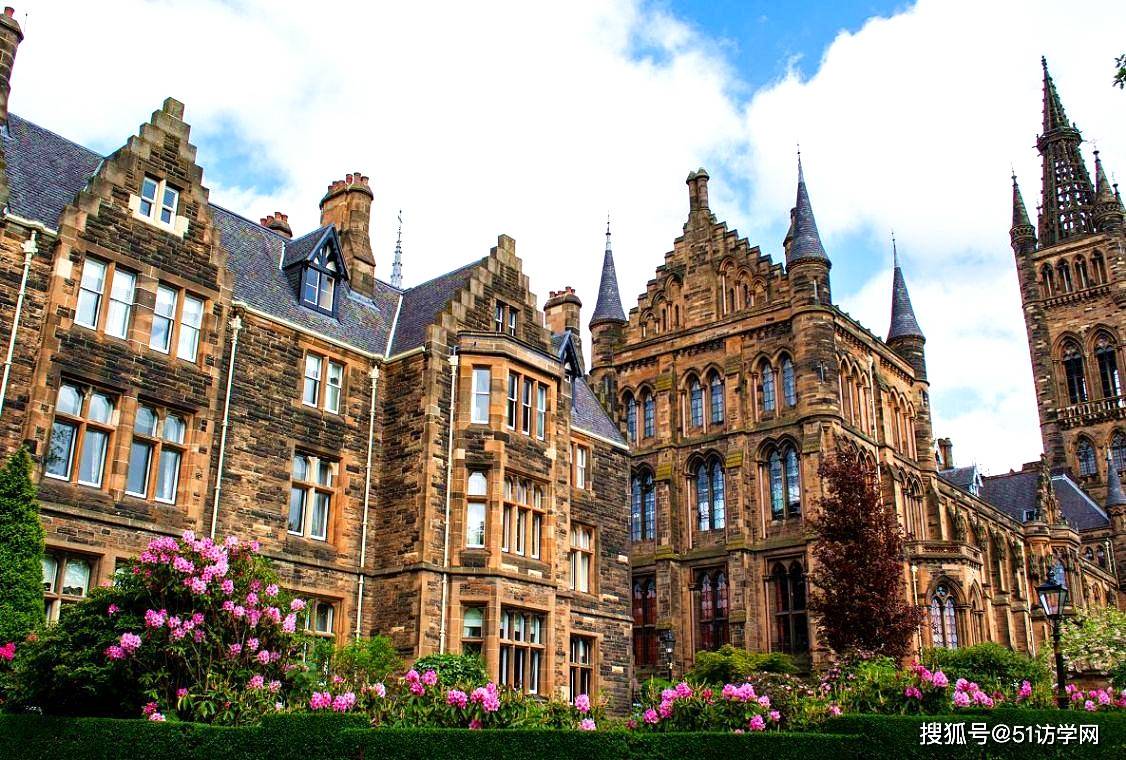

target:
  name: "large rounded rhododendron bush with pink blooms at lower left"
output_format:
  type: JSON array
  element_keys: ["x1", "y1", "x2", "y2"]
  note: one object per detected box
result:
[{"x1": 9, "y1": 531, "x2": 305, "y2": 724}]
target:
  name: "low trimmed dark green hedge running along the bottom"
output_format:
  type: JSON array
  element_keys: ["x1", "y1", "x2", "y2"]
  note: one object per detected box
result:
[{"x1": 0, "y1": 710, "x2": 1126, "y2": 760}]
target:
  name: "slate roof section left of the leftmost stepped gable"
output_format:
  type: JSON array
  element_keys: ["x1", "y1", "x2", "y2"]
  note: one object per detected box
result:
[{"x1": 3, "y1": 114, "x2": 101, "y2": 227}]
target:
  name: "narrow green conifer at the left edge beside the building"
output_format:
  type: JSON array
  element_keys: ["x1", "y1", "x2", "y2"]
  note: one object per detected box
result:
[{"x1": 0, "y1": 447, "x2": 43, "y2": 644}]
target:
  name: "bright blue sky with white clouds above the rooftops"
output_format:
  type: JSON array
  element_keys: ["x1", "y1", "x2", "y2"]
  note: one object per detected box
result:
[{"x1": 11, "y1": 0, "x2": 1126, "y2": 473}]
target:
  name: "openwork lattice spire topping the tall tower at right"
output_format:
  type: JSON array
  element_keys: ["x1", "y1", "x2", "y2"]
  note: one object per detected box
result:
[{"x1": 1036, "y1": 57, "x2": 1094, "y2": 245}]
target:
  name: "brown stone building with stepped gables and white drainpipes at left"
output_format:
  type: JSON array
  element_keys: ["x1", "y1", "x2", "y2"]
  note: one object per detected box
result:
[{"x1": 0, "y1": 10, "x2": 631, "y2": 707}]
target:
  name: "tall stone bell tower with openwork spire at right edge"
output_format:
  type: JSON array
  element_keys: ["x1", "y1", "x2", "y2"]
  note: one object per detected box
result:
[{"x1": 1010, "y1": 59, "x2": 1126, "y2": 501}]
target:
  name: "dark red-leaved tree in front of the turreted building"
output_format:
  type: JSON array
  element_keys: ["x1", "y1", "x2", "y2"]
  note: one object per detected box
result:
[{"x1": 810, "y1": 448, "x2": 922, "y2": 658}]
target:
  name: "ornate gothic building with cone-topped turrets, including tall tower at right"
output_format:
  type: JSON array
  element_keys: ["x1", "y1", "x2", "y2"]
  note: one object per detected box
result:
[{"x1": 590, "y1": 62, "x2": 1126, "y2": 673}]
